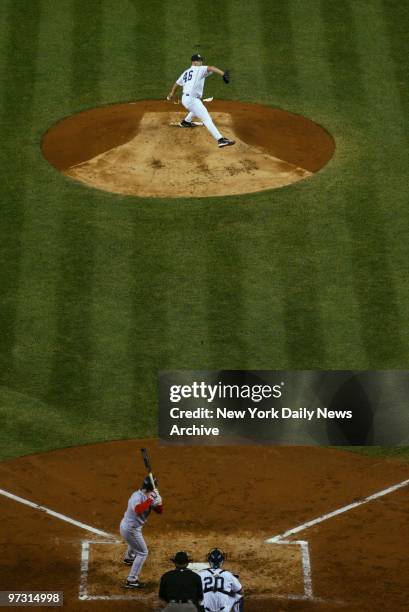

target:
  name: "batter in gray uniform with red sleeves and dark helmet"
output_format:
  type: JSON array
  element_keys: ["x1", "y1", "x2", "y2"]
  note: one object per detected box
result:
[{"x1": 119, "y1": 476, "x2": 163, "y2": 589}]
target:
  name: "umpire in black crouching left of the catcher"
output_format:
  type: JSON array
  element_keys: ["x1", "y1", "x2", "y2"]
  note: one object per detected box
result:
[{"x1": 159, "y1": 552, "x2": 203, "y2": 612}]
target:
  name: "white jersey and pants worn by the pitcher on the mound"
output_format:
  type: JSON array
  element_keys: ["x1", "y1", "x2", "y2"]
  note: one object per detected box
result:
[{"x1": 176, "y1": 66, "x2": 222, "y2": 140}]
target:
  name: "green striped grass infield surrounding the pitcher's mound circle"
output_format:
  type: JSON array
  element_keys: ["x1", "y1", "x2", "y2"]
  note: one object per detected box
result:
[{"x1": 0, "y1": 0, "x2": 409, "y2": 459}]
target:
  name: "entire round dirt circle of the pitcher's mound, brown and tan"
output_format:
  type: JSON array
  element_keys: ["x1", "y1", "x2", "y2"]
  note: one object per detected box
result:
[{"x1": 41, "y1": 100, "x2": 335, "y2": 198}]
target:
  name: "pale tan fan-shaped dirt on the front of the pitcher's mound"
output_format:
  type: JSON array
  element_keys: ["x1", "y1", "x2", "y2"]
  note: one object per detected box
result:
[{"x1": 65, "y1": 113, "x2": 311, "y2": 197}]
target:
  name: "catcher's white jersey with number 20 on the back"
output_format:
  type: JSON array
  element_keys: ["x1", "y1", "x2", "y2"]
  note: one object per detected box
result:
[{"x1": 199, "y1": 567, "x2": 242, "y2": 612}]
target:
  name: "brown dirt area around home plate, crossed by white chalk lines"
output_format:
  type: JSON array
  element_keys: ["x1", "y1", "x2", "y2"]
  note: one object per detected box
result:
[{"x1": 0, "y1": 440, "x2": 409, "y2": 612}]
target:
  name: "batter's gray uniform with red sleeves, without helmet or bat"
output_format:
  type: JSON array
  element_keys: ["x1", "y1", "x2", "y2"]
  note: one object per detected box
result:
[{"x1": 119, "y1": 489, "x2": 162, "y2": 580}]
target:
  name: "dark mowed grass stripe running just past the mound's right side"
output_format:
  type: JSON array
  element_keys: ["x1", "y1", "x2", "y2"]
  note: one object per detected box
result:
[{"x1": 322, "y1": 3, "x2": 403, "y2": 368}]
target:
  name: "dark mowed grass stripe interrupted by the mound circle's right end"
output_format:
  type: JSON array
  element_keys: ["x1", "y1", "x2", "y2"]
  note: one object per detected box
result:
[{"x1": 264, "y1": 3, "x2": 330, "y2": 369}]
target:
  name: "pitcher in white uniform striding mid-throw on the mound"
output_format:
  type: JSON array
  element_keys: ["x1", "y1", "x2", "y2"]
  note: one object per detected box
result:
[{"x1": 167, "y1": 53, "x2": 235, "y2": 147}]
